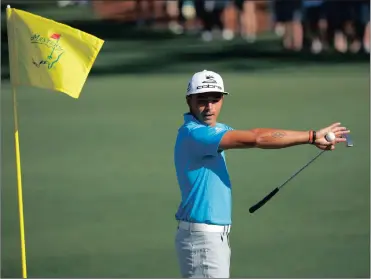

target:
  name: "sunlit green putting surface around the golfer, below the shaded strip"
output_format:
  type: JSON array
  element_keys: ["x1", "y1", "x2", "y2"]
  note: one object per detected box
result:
[{"x1": 1, "y1": 65, "x2": 370, "y2": 278}]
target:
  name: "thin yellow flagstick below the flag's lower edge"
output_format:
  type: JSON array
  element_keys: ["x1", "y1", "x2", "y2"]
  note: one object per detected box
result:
[{"x1": 12, "y1": 86, "x2": 27, "y2": 278}]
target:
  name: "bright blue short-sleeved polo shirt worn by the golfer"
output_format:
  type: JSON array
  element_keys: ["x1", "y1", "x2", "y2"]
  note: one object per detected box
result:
[{"x1": 174, "y1": 113, "x2": 232, "y2": 225}]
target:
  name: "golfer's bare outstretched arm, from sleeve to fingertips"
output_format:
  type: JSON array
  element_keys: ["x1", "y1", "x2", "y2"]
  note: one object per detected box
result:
[{"x1": 219, "y1": 123, "x2": 349, "y2": 150}]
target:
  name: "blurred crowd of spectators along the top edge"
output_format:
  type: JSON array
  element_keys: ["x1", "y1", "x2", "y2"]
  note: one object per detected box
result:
[{"x1": 58, "y1": 0, "x2": 370, "y2": 53}]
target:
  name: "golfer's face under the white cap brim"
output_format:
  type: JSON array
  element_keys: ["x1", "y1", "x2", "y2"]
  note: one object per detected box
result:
[{"x1": 190, "y1": 92, "x2": 223, "y2": 126}]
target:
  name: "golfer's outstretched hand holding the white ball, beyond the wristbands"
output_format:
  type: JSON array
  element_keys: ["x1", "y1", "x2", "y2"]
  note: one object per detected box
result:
[{"x1": 314, "y1": 122, "x2": 350, "y2": 150}]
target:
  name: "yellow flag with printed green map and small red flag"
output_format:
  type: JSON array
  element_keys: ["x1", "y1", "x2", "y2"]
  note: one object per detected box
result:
[{"x1": 6, "y1": 8, "x2": 104, "y2": 98}]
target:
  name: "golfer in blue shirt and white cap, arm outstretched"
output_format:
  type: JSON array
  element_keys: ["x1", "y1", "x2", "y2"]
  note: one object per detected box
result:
[{"x1": 174, "y1": 70, "x2": 349, "y2": 278}]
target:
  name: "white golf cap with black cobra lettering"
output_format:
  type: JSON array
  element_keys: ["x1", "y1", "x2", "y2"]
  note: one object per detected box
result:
[{"x1": 186, "y1": 70, "x2": 229, "y2": 96}]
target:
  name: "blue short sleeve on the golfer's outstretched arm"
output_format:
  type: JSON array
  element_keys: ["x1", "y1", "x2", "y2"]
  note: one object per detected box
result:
[{"x1": 189, "y1": 126, "x2": 229, "y2": 157}]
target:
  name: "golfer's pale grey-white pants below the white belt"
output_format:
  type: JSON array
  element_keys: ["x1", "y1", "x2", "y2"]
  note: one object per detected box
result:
[{"x1": 175, "y1": 224, "x2": 231, "y2": 278}]
